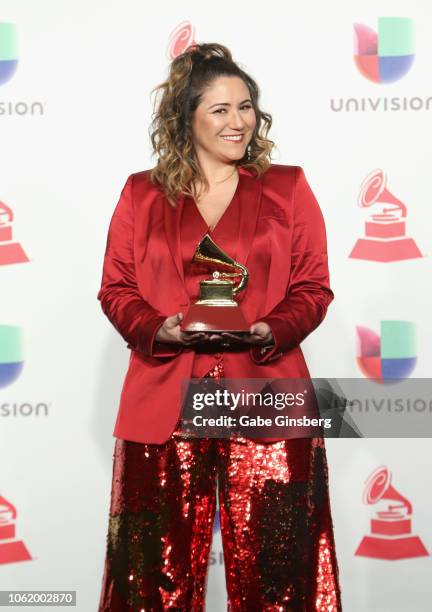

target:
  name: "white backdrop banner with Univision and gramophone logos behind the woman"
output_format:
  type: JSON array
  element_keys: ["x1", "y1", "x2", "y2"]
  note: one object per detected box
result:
[{"x1": 0, "y1": 0, "x2": 432, "y2": 612}]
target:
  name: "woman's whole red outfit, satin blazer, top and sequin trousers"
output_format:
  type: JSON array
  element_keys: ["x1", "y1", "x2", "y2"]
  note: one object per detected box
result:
[{"x1": 99, "y1": 166, "x2": 341, "y2": 612}]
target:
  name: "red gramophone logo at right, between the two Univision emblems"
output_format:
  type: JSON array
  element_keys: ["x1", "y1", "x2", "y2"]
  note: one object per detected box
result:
[{"x1": 350, "y1": 169, "x2": 423, "y2": 262}]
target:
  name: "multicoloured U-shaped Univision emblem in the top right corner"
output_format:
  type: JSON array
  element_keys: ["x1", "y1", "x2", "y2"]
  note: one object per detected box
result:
[{"x1": 354, "y1": 17, "x2": 414, "y2": 83}]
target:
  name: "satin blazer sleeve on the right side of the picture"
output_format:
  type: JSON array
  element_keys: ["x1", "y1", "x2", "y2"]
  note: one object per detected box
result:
[{"x1": 251, "y1": 168, "x2": 334, "y2": 363}]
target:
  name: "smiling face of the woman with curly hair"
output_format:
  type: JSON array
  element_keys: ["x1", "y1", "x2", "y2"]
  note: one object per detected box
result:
[{"x1": 192, "y1": 76, "x2": 256, "y2": 163}]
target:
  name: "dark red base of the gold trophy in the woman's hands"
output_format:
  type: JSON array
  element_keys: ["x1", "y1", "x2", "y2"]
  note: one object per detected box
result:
[{"x1": 180, "y1": 304, "x2": 249, "y2": 336}]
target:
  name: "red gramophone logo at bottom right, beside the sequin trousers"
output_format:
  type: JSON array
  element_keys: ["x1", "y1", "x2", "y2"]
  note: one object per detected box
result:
[{"x1": 355, "y1": 466, "x2": 429, "y2": 561}]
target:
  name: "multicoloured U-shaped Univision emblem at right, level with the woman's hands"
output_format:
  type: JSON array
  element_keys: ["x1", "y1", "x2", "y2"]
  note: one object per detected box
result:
[{"x1": 356, "y1": 321, "x2": 417, "y2": 383}]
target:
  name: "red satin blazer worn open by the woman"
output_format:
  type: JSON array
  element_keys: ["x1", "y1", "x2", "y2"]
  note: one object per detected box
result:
[{"x1": 98, "y1": 165, "x2": 333, "y2": 444}]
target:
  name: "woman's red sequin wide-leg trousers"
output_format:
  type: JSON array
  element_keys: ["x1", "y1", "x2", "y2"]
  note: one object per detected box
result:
[{"x1": 99, "y1": 359, "x2": 342, "y2": 612}]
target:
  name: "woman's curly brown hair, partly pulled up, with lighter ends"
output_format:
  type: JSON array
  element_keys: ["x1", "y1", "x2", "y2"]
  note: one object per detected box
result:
[{"x1": 150, "y1": 43, "x2": 274, "y2": 206}]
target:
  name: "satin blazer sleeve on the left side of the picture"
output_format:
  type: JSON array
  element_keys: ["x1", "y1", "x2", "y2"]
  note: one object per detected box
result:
[{"x1": 97, "y1": 175, "x2": 183, "y2": 357}]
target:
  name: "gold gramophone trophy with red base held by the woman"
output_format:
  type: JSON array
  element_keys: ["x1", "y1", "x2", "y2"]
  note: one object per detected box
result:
[{"x1": 181, "y1": 234, "x2": 250, "y2": 336}]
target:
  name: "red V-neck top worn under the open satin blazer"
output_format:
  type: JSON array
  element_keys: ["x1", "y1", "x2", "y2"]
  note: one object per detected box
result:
[{"x1": 180, "y1": 180, "x2": 240, "y2": 378}]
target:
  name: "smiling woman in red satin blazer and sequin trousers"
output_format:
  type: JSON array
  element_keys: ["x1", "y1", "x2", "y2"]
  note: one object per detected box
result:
[{"x1": 98, "y1": 44, "x2": 341, "y2": 612}]
